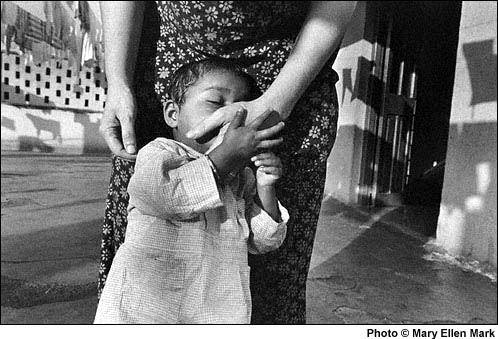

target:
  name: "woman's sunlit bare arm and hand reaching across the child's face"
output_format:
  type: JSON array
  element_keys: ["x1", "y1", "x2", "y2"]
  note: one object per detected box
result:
[{"x1": 187, "y1": 1, "x2": 356, "y2": 139}]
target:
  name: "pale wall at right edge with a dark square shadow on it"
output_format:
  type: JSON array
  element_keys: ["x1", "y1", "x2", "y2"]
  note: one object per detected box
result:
[{"x1": 437, "y1": 1, "x2": 497, "y2": 267}]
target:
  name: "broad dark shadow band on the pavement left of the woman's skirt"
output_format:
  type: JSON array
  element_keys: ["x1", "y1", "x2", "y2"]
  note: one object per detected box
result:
[{"x1": 1, "y1": 219, "x2": 102, "y2": 308}]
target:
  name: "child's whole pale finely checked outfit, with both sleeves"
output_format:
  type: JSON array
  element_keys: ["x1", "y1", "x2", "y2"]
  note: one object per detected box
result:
[{"x1": 95, "y1": 138, "x2": 289, "y2": 324}]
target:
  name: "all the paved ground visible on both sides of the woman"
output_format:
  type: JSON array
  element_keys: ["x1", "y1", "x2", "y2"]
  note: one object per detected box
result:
[{"x1": 1, "y1": 152, "x2": 497, "y2": 324}]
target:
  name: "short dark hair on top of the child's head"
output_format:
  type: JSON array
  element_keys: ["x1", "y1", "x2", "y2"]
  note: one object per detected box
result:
[{"x1": 168, "y1": 58, "x2": 261, "y2": 105}]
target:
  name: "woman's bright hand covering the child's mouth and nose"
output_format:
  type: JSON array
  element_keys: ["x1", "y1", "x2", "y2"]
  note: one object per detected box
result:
[{"x1": 186, "y1": 99, "x2": 273, "y2": 139}]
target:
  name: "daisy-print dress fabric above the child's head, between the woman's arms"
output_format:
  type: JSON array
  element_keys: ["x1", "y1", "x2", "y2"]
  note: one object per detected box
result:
[{"x1": 155, "y1": 1, "x2": 309, "y2": 102}]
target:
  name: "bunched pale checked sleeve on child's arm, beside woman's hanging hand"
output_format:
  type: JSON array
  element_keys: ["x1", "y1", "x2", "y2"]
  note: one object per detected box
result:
[{"x1": 128, "y1": 142, "x2": 223, "y2": 220}]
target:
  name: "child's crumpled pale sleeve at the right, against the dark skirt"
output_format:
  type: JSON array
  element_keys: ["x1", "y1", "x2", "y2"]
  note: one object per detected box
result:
[{"x1": 244, "y1": 168, "x2": 289, "y2": 254}]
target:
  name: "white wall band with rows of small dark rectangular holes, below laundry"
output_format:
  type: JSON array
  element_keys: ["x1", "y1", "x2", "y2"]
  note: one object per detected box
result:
[{"x1": 1, "y1": 52, "x2": 107, "y2": 112}]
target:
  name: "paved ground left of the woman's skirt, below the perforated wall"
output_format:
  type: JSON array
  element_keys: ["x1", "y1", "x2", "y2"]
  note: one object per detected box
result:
[{"x1": 1, "y1": 152, "x2": 110, "y2": 324}]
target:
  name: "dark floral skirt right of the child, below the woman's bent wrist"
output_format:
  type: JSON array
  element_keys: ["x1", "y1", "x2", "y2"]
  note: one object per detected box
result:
[{"x1": 249, "y1": 70, "x2": 337, "y2": 324}]
